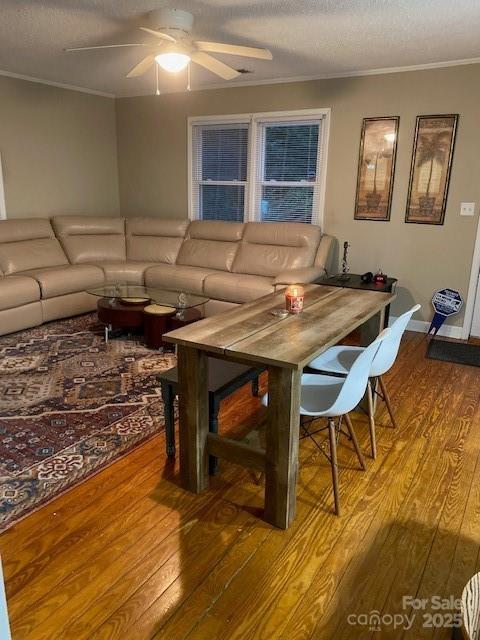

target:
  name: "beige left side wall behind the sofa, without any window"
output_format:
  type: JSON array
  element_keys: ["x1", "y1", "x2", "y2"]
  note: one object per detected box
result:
[{"x1": 0, "y1": 76, "x2": 119, "y2": 218}]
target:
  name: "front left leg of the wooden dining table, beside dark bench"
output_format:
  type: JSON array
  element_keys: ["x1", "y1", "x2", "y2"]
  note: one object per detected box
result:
[{"x1": 177, "y1": 345, "x2": 209, "y2": 493}]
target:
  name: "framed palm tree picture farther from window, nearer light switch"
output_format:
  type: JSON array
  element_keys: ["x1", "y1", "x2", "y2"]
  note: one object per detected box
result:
[{"x1": 405, "y1": 113, "x2": 458, "y2": 225}]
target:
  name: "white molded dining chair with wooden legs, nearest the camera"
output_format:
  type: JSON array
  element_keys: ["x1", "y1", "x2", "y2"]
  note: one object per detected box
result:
[{"x1": 262, "y1": 329, "x2": 390, "y2": 515}]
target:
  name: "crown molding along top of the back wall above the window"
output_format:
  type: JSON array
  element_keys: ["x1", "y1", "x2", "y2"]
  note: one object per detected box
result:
[{"x1": 117, "y1": 58, "x2": 480, "y2": 98}]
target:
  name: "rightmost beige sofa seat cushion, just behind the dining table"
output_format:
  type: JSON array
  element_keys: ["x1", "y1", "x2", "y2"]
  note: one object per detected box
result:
[{"x1": 203, "y1": 273, "x2": 274, "y2": 302}]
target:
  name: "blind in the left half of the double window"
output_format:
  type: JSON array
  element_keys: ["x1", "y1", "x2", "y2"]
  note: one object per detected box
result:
[{"x1": 192, "y1": 123, "x2": 248, "y2": 222}]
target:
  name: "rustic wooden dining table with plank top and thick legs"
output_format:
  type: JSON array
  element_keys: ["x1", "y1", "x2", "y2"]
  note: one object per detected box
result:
[{"x1": 164, "y1": 284, "x2": 395, "y2": 529}]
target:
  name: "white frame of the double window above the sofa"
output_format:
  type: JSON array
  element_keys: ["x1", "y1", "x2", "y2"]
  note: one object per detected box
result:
[{"x1": 187, "y1": 108, "x2": 331, "y2": 227}]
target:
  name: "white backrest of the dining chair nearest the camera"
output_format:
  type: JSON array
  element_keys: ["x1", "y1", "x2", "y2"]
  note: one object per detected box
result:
[{"x1": 328, "y1": 329, "x2": 390, "y2": 417}]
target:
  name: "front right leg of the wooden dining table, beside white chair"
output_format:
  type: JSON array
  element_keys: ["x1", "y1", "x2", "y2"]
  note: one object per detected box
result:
[{"x1": 265, "y1": 366, "x2": 301, "y2": 529}]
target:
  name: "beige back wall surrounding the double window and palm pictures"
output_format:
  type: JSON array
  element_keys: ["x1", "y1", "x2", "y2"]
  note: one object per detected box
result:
[{"x1": 116, "y1": 65, "x2": 480, "y2": 324}]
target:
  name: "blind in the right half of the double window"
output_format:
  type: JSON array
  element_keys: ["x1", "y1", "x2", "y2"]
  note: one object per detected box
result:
[{"x1": 255, "y1": 120, "x2": 322, "y2": 223}]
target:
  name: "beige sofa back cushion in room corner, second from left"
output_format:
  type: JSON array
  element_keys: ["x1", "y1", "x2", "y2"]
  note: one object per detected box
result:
[{"x1": 52, "y1": 216, "x2": 126, "y2": 264}]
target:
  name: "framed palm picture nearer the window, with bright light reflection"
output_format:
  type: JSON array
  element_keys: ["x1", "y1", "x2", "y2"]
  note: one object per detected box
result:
[{"x1": 354, "y1": 116, "x2": 400, "y2": 222}]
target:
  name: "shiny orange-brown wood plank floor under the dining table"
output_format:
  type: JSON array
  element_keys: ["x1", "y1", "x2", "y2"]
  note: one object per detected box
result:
[{"x1": 0, "y1": 333, "x2": 480, "y2": 640}]
